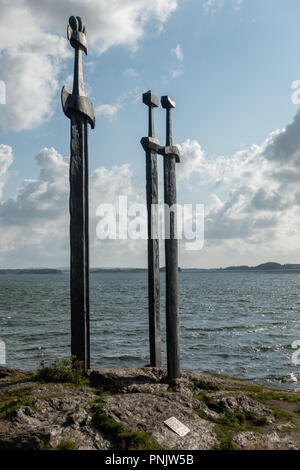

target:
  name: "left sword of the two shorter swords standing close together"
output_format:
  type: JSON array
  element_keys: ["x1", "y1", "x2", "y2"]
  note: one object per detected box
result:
[{"x1": 141, "y1": 91, "x2": 161, "y2": 367}]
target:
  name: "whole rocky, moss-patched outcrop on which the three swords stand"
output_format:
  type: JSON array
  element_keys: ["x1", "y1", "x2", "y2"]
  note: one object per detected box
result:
[{"x1": 0, "y1": 367, "x2": 300, "y2": 450}]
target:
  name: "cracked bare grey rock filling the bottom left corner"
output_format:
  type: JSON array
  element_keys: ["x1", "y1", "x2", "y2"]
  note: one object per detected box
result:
[{"x1": 0, "y1": 384, "x2": 110, "y2": 450}]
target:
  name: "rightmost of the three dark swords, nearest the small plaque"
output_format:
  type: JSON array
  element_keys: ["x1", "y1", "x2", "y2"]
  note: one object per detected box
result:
[{"x1": 158, "y1": 96, "x2": 180, "y2": 380}]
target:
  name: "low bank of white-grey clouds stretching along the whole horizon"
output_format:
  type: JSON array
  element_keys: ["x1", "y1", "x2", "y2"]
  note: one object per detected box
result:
[{"x1": 4, "y1": 106, "x2": 300, "y2": 267}]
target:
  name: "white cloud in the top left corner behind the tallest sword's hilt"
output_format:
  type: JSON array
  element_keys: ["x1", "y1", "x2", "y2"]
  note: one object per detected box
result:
[{"x1": 0, "y1": 0, "x2": 177, "y2": 131}]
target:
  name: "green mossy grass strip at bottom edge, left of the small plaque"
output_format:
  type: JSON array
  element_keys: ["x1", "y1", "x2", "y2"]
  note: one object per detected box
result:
[{"x1": 92, "y1": 409, "x2": 163, "y2": 450}]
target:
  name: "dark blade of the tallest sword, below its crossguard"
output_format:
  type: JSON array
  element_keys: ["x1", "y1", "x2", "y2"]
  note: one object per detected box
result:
[{"x1": 70, "y1": 114, "x2": 90, "y2": 370}]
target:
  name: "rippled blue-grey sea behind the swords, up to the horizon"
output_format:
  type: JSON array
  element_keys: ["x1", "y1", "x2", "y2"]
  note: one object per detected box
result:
[{"x1": 0, "y1": 272, "x2": 300, "y2": 388}]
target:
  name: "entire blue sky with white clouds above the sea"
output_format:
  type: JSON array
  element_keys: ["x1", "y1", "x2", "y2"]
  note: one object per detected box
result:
[{"x1": 0, "y1": 0, "x2": 300, "y2": 268}]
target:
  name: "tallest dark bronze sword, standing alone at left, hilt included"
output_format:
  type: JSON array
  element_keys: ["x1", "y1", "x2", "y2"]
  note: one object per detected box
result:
[{"x1": 61, "y1": 16, "x2": 95, "y2": 370}]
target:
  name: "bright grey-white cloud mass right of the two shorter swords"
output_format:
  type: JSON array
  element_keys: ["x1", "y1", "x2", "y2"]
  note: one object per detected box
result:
[{"x1": 178, "y1": 113, "x2": 300, "y2": 260}]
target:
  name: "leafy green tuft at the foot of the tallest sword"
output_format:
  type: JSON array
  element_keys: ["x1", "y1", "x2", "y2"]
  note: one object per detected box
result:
[{"x1": 35, "y1": 357, "x2": 89, "y2": 385}]
